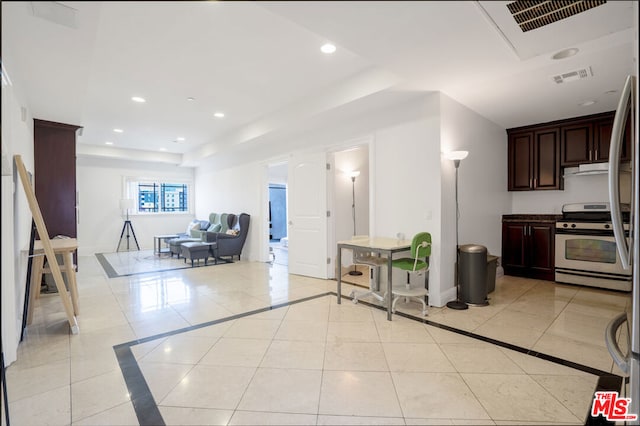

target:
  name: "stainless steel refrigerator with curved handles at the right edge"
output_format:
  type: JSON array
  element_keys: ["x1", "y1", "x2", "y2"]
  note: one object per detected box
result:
[{"x1": 605, "y1": 76, "x2": 640, "y2": 424}]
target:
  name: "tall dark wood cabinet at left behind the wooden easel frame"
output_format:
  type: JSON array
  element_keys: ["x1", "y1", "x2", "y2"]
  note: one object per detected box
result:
[{"x1": 33, "y1": 119, "x2": 80, "y2": 238}]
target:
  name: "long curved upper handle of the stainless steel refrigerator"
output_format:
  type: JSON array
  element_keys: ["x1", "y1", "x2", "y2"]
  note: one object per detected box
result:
[{"x1": 609, "y1": 75, "x2": 634, "y2": 269}]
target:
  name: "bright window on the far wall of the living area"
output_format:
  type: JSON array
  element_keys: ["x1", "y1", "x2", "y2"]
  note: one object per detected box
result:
[{"x1": 126, "y1": 179, "x2": 191, "y2": 214}]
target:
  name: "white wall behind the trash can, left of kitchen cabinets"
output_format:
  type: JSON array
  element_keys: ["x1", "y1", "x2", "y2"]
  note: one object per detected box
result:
[{"x1": 440, "y1": 94, "x2": 511, "y2": 302}]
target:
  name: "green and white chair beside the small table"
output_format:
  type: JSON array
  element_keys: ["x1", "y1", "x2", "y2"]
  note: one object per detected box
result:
[{"x1": 391, "y1": 232, "x2": 431, "y2": 315}]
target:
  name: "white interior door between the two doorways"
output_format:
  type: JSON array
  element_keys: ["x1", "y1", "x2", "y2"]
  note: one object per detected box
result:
[{"x1": 288, "y1": 153, "x2": 327, "y2": 279}]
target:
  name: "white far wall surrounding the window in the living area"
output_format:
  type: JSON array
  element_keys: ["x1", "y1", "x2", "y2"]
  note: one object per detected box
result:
[{"x1": 76, "y1": 157, "x2": 195, "y2": 255}]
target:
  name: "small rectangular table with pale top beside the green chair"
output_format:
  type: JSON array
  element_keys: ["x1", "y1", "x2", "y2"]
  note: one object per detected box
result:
[{"x1": 338, "y1": 237, "x2": 411, "y2": 321}]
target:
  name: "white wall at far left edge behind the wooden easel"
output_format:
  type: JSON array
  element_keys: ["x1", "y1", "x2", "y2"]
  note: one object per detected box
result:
[{"x1": 2, "y1": 70, "x2": 33, "y2": 365}]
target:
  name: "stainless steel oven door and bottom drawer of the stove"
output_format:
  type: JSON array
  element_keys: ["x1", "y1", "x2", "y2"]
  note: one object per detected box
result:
[{"x1": 555, "y1": 230, "x2": 631, "y2": 291}]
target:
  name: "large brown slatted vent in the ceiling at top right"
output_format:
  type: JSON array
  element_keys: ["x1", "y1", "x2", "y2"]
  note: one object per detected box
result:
[{"x1": 507, "y1": 0, "x2": 607, "y2": 33}]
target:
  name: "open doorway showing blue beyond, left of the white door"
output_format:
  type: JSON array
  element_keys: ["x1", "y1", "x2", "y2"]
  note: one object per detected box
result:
[{"x1": 268, "y1": 163, "x2": 289, "y2": 266}]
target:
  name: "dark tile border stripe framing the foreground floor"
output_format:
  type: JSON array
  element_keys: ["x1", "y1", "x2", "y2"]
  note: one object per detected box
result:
[{"x1": 114, "y1": 292, "x2": 623, "y2": 426}]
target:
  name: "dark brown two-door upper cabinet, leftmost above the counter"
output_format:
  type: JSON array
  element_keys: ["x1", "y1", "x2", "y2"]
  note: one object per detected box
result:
[{"x1": 507, "y1": 128, "x2": 564, "y2": 191}]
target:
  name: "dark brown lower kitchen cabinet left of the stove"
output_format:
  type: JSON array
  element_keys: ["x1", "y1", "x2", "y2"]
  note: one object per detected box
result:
[{"x1": 502, "y1": 215, "x2": 556, "y2": 281}]
